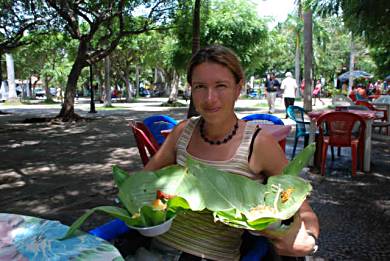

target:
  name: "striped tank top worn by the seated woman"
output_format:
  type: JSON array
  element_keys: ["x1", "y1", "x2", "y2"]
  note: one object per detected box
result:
[{"x1": 158, "y1": 117, "x2": 262, "y2": 260}]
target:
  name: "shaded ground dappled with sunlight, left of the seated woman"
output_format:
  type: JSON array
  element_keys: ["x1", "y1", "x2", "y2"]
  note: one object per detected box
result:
[{"x1": 0, "y1": 99, "x2": 189, "y2": 229}]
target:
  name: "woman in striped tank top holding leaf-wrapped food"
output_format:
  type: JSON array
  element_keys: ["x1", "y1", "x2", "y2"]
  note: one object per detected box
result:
[{"x1": 145, "y1": 46, "x2": 319, "y2": 260}]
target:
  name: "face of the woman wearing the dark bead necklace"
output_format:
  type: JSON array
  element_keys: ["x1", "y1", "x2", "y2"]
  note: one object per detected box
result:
[{"x1": 191, "y1": 63, "x2": 241, "y2": 121}]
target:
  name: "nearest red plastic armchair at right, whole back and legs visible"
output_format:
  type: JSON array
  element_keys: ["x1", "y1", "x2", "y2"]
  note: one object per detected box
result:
[{"x1": 317, "y1": 111, "x2": 366, "y2": 176}]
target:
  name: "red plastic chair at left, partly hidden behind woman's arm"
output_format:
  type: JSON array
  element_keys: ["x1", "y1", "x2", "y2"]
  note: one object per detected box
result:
[{"x1": 129, "y1": 121, "x2": 160, "y2": 166}]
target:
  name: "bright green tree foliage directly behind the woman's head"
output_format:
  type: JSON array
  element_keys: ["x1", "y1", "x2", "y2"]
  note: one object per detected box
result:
[{"x1": 173, "y1": 0, "x2": 268, "y2": 74}]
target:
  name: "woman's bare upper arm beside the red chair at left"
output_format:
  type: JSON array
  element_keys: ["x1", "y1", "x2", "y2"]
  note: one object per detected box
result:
[{"x1": 144, "y1": 121, "x2": 187, "y2": 170}]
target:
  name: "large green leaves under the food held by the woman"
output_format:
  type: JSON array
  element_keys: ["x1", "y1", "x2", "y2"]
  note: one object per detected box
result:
[{"x1": 65, "y1": 144, "x2": 315, "y2": 237}]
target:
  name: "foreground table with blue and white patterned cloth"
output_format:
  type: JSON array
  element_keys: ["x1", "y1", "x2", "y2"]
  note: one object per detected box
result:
[{"x1": 0, "y1": 213, "x2": 124, "y2": 261}]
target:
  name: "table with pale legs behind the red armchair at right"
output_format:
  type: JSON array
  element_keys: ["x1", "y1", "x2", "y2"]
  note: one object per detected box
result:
[{"x1": 308, "y1": 110, "x2": 378, "y2": 172}]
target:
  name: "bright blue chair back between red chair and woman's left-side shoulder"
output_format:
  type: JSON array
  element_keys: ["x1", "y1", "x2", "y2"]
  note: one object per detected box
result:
[{"x1": 144, "y1": 115, "x2": 177, "y2": 145}]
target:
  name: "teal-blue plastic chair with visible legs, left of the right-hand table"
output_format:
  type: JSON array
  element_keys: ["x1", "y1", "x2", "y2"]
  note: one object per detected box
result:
[{"x1": 287, "y1": 105, "x2": 310, "y2": 158}]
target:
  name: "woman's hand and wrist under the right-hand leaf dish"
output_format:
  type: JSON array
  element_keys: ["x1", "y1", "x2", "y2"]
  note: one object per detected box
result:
[{"x1": 261, "y1": 214, "x2": 315, "y2": 256}]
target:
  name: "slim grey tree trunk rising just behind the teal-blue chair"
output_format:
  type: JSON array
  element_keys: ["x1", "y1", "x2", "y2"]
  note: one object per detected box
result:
[{"x1": 303, "y1": 9, "x2": 313, "y2": 111}]
